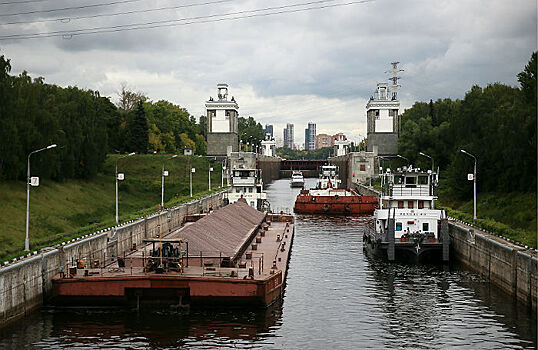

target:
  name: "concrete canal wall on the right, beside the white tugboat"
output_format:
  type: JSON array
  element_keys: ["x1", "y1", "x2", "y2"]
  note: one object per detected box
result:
[{"x1": 354, "y1": 184, "x2": 538, "y2": 312}]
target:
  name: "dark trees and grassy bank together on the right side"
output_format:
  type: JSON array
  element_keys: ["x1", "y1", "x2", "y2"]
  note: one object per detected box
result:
[{"x1": 398, "y1": 52, "x2": 538, "y2": 247}]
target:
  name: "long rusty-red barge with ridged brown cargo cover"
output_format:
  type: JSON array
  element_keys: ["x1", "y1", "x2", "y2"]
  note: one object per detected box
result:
[{"x1": 52, "y1": 201, "x2": 295, "y2": 309}]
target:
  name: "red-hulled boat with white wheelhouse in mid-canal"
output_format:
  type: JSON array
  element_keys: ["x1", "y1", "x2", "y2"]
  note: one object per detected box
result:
[{"x1": 293, "y1": 165, "x2": 378, "y2": 215}]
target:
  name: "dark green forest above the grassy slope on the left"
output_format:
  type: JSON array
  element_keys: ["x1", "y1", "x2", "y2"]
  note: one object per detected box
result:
[{"x1": 0, "y1": 56, "x2": 207, "y2": 181}]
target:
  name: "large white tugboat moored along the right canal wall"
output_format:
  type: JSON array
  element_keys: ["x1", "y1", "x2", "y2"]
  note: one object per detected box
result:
[{"x1": 363, "y1": 167, "x2": 450, "y2": 261}]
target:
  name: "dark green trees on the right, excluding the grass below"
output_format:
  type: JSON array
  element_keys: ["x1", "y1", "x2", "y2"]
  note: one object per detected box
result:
[{"x1": 398, "y1": 52, "x2": 537, "y2": 199}]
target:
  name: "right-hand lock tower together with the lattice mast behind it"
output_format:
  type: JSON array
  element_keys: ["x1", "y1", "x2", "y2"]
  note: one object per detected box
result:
[{"x1": 366, "y1": 62, "x2": 403, "y2": 155}]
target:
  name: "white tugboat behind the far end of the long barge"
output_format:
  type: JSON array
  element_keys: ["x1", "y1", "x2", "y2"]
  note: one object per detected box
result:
[{"x1": 224, "y1": 169, "x2": 270, "y2": 211}]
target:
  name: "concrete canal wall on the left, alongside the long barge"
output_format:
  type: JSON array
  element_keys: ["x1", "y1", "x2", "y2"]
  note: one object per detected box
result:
[{"x1": 0, "y1": 193, "x2": 222, "y2": 327}]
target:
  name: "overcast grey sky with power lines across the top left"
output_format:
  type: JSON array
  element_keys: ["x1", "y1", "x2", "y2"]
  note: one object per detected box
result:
[{"x1": 0, "y1": 0, "x2": 537, "y2": 145}]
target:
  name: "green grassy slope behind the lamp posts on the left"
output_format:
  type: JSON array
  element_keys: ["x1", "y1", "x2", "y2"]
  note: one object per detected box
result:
[{"x1": 0, "y1": 155, "x2": 221, "y2": 261}]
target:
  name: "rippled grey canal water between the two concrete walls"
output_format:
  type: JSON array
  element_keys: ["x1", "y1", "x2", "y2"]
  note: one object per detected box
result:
[{"x1": 0, "y1": 179, "x2": 537, "y2": 349}]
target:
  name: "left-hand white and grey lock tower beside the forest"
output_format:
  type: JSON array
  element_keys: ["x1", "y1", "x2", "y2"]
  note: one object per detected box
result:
[{"x1": 205, "y1": 84, "x2": 239, "y2": 156}]
